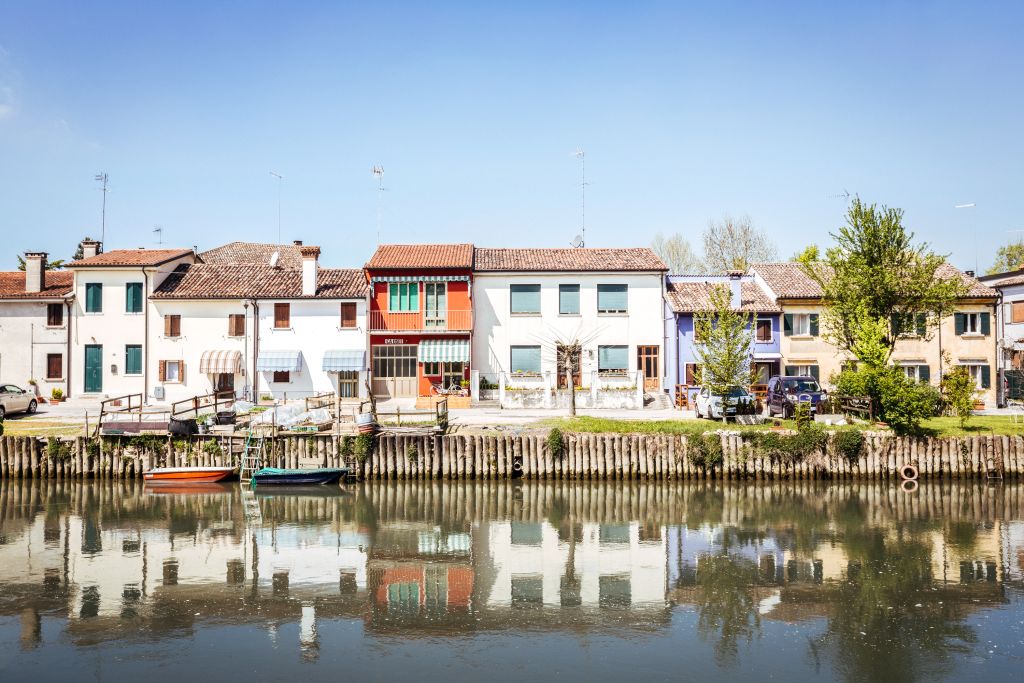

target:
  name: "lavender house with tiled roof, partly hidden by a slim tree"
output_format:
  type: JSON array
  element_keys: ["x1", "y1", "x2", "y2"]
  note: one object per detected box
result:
[{"x1": 665, "y1": 271, "x2": 782, "y2": 400}]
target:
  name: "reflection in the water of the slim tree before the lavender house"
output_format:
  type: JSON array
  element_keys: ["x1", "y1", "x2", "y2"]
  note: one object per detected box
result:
[{"x1": 696, "y1": 554, "x2": 761, "y2": 666}]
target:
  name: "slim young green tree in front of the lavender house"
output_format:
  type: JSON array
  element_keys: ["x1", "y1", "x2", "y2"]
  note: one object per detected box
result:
[{"x1": 693, "y1": 285, "x2": 754, "y2": 422}]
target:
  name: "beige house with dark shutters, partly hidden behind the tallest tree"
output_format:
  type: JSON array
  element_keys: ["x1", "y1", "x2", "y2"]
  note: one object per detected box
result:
[{"x1": 752, "y1": 263, "x2": 998, "y2": 408}]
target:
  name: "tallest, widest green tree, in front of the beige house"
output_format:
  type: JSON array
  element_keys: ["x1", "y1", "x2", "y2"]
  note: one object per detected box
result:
[{"x1": 801, "y1": 198, "x2": 968, "y2": 367}]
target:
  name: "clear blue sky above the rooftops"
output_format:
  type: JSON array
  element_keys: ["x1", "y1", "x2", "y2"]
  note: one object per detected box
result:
[{"x1": 0, "y1": 0, "x2": 1024, "y2": 268}]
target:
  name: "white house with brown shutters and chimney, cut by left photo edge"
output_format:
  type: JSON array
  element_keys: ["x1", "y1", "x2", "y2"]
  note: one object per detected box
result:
[{"x1": 0, "y1": 252, "x2": 73, "y2": 398}]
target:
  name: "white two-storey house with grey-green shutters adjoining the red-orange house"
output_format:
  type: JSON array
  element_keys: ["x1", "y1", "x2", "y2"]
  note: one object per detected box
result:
[{"x1": 472, "y1": 248, "x2": 667, "y2": 405}]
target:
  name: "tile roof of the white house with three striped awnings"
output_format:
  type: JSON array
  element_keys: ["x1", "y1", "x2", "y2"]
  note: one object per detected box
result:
[{"x1": 153, "y1": 263, "x2": 368, "y2": 299}]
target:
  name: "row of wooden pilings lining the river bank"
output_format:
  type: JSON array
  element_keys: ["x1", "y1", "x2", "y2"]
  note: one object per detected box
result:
[{"x1": 0, "y1": 432, "x2": 1024, "y2": 480}]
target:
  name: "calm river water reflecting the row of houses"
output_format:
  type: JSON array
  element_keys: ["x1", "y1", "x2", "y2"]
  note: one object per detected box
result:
[{"x1": 0, "y1": 482, "x2": 1024, "y2": 683}]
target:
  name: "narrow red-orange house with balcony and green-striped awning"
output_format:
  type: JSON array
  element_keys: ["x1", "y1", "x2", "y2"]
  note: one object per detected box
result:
[{"x1": 365, "y1": 244, "x2": 473, "y2": 398}]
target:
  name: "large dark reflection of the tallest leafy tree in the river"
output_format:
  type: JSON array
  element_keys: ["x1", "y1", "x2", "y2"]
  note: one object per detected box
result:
[{"x1": 811, "y1": 525, "x2": 976, "y2": 681}]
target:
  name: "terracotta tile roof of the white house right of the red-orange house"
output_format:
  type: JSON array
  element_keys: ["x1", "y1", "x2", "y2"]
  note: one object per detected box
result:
[{"x1": 474, "y1": 248, "x2": 668, "y2": 272}]
